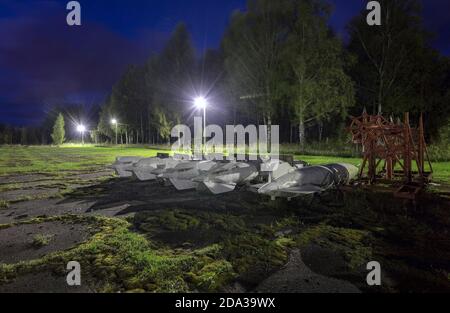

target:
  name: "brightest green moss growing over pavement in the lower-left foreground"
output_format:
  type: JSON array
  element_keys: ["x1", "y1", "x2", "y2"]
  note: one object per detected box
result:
[{"x1": 0, "y1": 215, "x2": 243, "y2": 292}]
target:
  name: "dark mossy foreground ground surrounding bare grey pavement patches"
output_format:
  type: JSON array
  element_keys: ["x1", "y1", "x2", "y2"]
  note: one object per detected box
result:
[{"x1": 0, "y1": 186, "x2": 450, "y2": 292}]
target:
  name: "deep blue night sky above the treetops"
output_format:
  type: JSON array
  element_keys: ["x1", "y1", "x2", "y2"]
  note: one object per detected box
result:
[{"x1": 0, "y1": 0, "x2": 450, "y2": 126}]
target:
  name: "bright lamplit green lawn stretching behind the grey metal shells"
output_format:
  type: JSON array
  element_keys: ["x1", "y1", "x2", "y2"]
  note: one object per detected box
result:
[{"x1": 0, "y1": 145, "x2": 450, "y2": 183}]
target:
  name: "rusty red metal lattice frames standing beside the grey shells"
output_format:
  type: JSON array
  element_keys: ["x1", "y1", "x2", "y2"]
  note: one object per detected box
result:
[{"x1": 348, "y1": 112, "x2": 433, "y2": 185}]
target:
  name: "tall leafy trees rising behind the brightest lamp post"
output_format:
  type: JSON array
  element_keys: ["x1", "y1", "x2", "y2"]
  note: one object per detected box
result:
[{"x1": 0, "y1": 0, "x2": 450, "y2": 146}]
